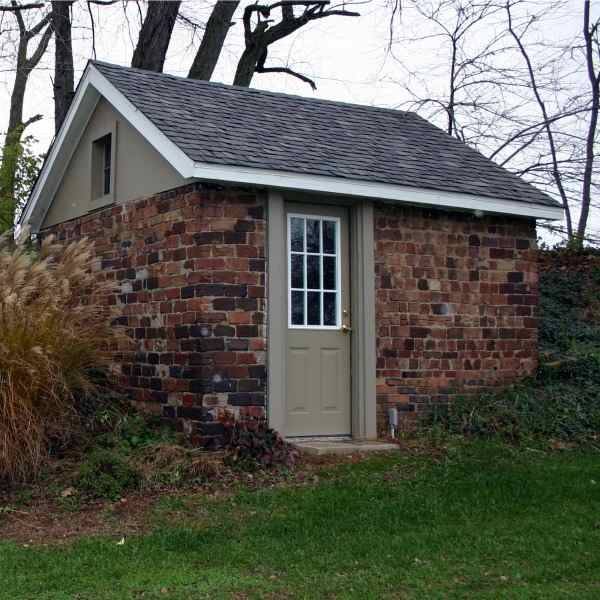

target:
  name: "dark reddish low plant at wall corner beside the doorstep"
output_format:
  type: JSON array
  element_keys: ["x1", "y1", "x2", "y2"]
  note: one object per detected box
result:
[{"x1": 221, "y1": 415, "x2": 298, "y2": 469}]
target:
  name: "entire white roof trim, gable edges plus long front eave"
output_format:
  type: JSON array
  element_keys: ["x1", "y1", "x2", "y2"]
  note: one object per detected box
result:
[{"x1": 20, "y1": 63, "x2": 563, "y2": 232}]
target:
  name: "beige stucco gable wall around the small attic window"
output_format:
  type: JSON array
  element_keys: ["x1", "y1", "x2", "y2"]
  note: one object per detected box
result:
[{"x1": 43, "y1": 98, "x2": 184, "y2": 227}]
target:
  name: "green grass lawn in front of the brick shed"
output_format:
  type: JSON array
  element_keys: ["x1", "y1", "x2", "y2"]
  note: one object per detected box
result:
[{"x1": 0, "y1": 443, "x2": 600, "y2": 600}]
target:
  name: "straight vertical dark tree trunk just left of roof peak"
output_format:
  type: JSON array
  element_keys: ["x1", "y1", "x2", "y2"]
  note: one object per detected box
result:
[{"x1": 52, "y1": 0, "x2": 74, "y2": 133}]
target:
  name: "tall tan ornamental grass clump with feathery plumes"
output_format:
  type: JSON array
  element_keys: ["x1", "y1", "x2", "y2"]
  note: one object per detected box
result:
[{"x1": 0, "y1": 230, "x2": 117, "y2": 481}]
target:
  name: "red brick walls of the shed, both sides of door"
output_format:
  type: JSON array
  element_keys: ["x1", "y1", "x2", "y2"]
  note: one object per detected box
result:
[{"x1": 42, "y1": 184, "x2": 537, "y2": 444}]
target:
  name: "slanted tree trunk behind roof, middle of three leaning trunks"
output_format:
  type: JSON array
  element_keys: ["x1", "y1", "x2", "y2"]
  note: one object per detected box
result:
[{"x1": 188, "y1": 0, "x2": 239, "y2": 81}]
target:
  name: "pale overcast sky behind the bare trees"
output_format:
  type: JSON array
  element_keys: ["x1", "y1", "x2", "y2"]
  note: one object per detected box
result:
[{"x1": 0, "y1": 0, "x2": 600, "y2": 241}]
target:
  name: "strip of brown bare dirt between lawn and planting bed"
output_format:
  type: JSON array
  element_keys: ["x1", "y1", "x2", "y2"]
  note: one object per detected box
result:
[{"x1": 0, "y1": 455, "x2": 364, "y2": 545}]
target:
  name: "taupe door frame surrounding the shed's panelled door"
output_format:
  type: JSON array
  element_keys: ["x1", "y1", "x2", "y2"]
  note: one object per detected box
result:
[{"x1": 267, "y1": 190, "x2": 377, "y2": 439}]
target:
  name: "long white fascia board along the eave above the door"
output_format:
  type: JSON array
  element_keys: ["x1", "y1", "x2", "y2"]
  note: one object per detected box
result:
[{"x1": 194, "y1": 163, "x2": 563, "y2": 220}]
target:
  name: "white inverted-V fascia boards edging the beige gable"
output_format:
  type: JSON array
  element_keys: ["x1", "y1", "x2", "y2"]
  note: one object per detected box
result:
[{"x1": 20, "y1": 64, "x2": 194, "y2": 233}]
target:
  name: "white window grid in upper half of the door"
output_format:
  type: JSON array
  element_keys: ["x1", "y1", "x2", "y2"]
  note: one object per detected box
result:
[{"x1": 287, "y1": 213, "x2": 342, "y2": 330}]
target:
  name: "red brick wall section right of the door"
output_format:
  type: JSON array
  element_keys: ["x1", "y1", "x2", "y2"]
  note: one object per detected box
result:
[{"x1": 375, "y1": 205, "x2": 538, "y2": 430}]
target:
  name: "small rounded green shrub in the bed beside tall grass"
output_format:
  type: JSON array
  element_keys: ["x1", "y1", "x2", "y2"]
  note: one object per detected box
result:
[{"x1": 75, "y1": 448, "x2": 140, "y2": 500}]
